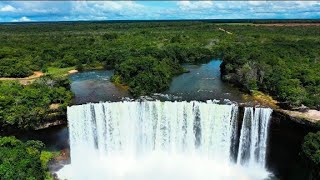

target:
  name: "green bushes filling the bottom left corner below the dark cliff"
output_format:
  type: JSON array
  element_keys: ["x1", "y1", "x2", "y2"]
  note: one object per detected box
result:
[{"x1": 0, "y1": 137, "x2": 53, "y2": 180}]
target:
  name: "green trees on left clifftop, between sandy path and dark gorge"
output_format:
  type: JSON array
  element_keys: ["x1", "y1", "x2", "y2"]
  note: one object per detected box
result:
[{"x1": 0, "y1": 76, "x2": 72, "y2": 131}]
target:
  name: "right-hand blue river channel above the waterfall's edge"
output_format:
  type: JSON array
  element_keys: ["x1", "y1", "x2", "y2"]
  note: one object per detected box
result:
[{"x1": 164, "y1": 60, "x2": 243, "y2": 102}]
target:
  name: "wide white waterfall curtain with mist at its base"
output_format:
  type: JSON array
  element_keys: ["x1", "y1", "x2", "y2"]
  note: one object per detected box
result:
[{"x1": 57, "y1": 101, "x2": 272, "y2": 180}]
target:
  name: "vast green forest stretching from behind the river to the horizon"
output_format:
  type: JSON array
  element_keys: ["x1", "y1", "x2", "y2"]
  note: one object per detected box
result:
[{"x1": 0, "y1": 21, "x2": 320, "y2": 108}]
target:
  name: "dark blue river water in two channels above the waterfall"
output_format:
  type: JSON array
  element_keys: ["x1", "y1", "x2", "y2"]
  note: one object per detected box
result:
[{"x1": 70, "y1": 60, "x2": 242, "y2": 104}]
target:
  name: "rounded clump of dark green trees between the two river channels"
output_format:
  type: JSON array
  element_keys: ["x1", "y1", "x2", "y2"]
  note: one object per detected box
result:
[{"x1": 112, "y1": 57, "x2": 184, "y2": 96}]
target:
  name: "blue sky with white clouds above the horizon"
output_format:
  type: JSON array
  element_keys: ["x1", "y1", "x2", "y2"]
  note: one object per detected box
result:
[{"x1": 0, "y1": 1, "x2": 320, "y2": 22}]
